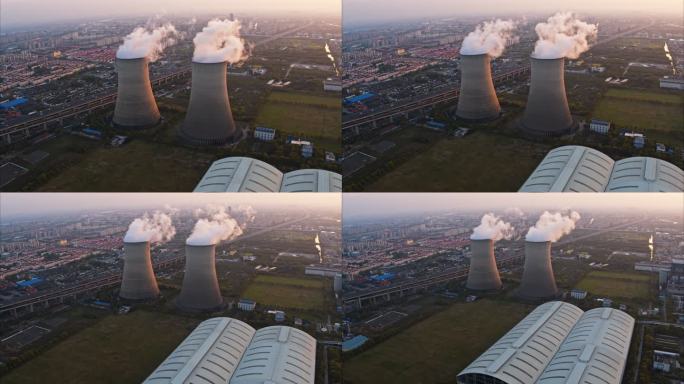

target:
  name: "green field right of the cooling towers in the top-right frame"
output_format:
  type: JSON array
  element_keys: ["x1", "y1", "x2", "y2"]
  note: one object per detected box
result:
[{"x1": 593, "y1": 89, "x2": 684, "y2": 145}]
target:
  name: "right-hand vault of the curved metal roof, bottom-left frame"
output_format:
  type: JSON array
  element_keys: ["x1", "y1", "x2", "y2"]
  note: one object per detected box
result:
[{"x1": 230, "y1": 326, "x2": 316, "y2": 384}]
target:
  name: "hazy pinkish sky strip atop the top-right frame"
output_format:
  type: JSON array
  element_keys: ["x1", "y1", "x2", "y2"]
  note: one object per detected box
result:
[{"x1": 342, "y1": 0, "x2": 684, "y2": 27}]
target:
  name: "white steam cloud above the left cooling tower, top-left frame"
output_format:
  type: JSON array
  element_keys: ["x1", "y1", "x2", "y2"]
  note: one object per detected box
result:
[{"x1": 116, "y1": 23, "x2": 178, "y2": 61}]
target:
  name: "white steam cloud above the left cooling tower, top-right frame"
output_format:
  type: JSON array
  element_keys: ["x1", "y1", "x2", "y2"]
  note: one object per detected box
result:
[{"x1": 461, "y1": 19, "x2": 518, "y2": 57}]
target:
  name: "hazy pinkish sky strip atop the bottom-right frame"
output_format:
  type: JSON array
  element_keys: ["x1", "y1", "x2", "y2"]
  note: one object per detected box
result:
[{"x1": 342, "y1": 193, "x2": 684, "y2": 219}]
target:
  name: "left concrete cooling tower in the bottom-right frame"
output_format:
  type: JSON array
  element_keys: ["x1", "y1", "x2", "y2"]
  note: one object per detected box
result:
[{"x1": 466, "y1": 239, "x2": 501, "y2": 291}]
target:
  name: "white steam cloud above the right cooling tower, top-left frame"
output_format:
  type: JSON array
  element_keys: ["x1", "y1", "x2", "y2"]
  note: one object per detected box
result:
[{"x1": 192, "y1": 19, "x2": 248, "y2": 64}]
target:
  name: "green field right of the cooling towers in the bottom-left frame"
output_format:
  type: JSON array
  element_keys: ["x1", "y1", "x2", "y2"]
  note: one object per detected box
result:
[{"x1": 242, "y1": 275, "x2": 330, "y2": 311}]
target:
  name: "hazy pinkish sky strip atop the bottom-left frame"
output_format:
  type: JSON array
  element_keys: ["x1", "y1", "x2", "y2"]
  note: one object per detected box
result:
[{"x1": 0, "y1": 193, "x2": 341, "y2": 219}]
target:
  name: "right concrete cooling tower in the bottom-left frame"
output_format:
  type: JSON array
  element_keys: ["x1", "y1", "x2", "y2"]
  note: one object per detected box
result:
[{"x1": 176, "y1": 245, "x2": 223, "y2": 311}]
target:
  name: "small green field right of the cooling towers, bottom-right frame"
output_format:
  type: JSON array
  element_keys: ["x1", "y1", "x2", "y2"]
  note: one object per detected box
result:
[{"x1": 577, "y1": 271, "x2": 653, "y2": 299}]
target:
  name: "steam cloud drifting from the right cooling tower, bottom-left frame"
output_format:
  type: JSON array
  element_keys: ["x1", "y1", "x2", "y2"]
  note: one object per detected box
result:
[{"x1": 185, "y1": 205, "x2": 255, "y2": 245}]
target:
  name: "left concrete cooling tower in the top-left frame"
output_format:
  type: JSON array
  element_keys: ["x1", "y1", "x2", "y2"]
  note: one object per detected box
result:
[{"x1": 113, "y1": 57, "x2": 161, "y2": 128}]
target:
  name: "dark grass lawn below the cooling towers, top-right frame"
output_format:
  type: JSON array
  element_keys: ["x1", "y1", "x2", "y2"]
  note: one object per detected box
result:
[{"x1": 365, "y1": 132, "x2": 550, "y2": 192}]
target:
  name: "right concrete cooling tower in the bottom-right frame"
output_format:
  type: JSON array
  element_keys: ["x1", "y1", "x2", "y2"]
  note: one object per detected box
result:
[{"x1": 518, "y1": 241, "x2": 558, "y2": 299}]
